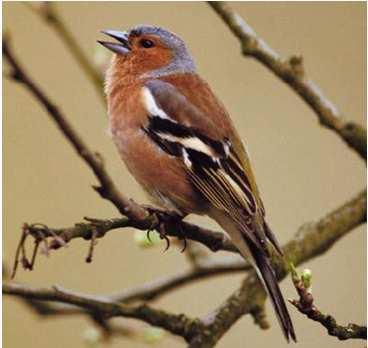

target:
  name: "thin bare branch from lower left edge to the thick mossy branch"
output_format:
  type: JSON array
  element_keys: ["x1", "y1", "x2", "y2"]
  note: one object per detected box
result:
[{"x1": 3, "y1": 284, "x2": 201, "y2": 340}]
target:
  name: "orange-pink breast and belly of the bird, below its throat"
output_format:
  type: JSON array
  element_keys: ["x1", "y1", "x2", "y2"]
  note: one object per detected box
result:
[{"x1": 108, "y1": 83, "x2": 206, "y2": 214}]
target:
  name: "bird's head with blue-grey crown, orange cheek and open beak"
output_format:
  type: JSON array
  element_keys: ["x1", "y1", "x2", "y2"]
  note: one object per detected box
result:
[{"x1": 99, "y1": 25, "x2": 195, "y2": 78}]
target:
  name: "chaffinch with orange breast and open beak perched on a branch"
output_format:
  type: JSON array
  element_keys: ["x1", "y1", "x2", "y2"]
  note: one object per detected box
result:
[{"x1": 98, "y1": 25, "x2": 296, "y2": 342}]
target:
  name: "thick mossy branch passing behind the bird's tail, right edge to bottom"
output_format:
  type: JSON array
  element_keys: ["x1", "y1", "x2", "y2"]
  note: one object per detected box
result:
[{"x1": 190, "y1": 191, "x2": 367, "y2": 348}]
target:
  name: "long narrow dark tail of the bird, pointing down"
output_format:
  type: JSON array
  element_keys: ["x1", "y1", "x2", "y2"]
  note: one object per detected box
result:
[{"x1": 247, "y1": 243, "x2": 296, "y2": 342}]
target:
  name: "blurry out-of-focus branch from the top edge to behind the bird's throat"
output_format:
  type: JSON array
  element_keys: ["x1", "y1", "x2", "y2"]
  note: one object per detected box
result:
[{"x1": 24, "y1": 1, "x2": 106, "y2": 105}]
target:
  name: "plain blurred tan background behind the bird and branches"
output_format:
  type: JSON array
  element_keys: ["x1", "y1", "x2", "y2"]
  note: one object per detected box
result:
[{"x1": 3, "y1": 2, "x2": 366, "y2": 348}]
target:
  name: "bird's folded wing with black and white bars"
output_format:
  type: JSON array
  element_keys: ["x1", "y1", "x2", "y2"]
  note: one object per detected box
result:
[{"x1": 143, "y1": 80, "x2": 278, "y2": 250}]
